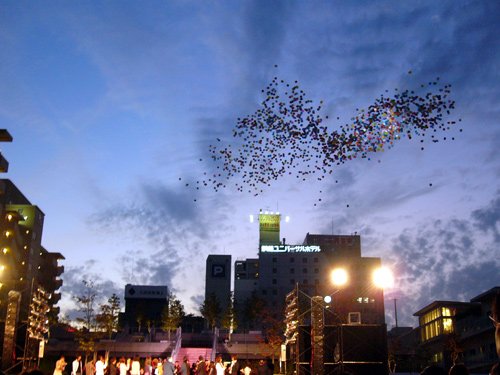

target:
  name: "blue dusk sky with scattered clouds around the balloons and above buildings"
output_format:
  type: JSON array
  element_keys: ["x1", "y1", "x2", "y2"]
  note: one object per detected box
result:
[{"x1": 0, "y1": 0, "x2": 500, "y2": 328}]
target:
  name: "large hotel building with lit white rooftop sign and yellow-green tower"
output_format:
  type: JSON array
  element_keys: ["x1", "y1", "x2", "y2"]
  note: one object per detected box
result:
[{"x1": 234, "y1": 213, "x2": 385, "y2": 324}]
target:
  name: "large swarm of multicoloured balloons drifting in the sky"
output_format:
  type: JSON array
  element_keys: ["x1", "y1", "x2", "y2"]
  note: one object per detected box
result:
[{"x1": 191, "y1": 68, "x2": 462, "y2": 201}]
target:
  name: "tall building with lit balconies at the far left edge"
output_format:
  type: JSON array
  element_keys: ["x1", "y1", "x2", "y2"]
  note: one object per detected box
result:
[{"x1": 0, "y1": 179, "x2": 64, "y2": 371}]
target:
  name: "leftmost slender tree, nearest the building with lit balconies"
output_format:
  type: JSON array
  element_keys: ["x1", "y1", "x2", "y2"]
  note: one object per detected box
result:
[{"x1": 73, "y1": 280, "x2": 99, "y2": 356}]
